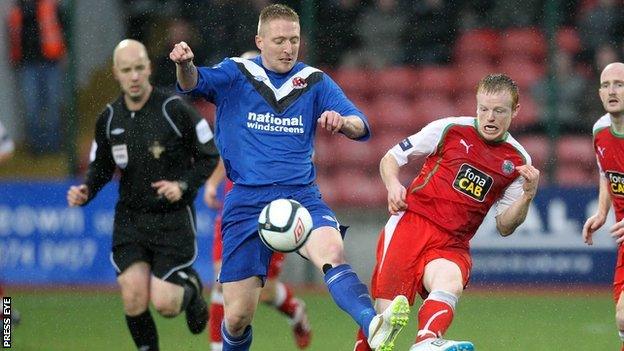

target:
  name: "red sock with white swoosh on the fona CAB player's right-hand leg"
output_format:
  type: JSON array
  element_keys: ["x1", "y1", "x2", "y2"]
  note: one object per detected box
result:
[{"x1": 416, "y1": 299, "x2": 453, "y2": 342}]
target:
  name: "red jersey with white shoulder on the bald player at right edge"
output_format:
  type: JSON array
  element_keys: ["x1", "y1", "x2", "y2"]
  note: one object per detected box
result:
[{"x1": 594, "y1": 113, "x2": 624, "y2": 222}]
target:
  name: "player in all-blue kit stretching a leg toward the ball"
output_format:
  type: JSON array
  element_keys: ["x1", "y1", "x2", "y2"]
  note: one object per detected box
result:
[{"x1": 169, "y1": 4, "x2": 409, "y2": 351}]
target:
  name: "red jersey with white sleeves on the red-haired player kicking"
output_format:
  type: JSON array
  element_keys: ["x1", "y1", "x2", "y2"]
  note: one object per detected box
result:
[{"x1": 389, "y1": 117, "x2": 531, "y2": 245}]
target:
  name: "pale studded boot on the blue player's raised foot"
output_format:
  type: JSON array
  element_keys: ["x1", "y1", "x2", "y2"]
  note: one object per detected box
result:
[{"x1": 368, "y1": 295, "x2": 410, "y2": 351}]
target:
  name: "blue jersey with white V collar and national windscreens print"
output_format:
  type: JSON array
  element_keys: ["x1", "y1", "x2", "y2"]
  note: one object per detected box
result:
[{"x1": 179, "y1": 56, "x2": 370, "y2": 186}]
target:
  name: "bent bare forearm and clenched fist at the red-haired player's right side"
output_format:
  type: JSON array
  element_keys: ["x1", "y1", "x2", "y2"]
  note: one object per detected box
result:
[{"x1": 496, "y1": 165, "x2": 540, "y2": 236}]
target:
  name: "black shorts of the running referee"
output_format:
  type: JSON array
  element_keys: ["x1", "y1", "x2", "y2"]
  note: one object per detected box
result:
[{"x1": 111, "y1": 205, "x2": 197, "y2": 281}]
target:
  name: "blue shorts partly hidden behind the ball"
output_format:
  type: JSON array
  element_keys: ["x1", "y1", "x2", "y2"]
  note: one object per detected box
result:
[{"x1": 219, "y1": 184, "x2": 339, "y2": 283}]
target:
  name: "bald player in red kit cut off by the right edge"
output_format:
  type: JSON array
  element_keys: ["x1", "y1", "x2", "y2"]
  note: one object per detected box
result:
[{"x1": 583, "y1": 62, "x2": 624, "y2": 351}]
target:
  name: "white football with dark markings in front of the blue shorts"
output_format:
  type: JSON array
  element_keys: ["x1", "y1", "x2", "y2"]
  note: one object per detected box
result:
[{"x1": 258, "y1": 199, "x2": 312, "y2": 252}]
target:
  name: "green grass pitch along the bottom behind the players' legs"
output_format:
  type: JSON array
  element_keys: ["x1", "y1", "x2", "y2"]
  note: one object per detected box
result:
[{"x1": 11, "y1": 287, "x2": 620, "y2": 351}]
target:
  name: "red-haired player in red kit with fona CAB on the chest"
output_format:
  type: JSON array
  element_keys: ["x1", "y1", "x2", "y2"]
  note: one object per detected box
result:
[{"x1": 355, "y1": 74, "x2": 539, "y2": 351}]
